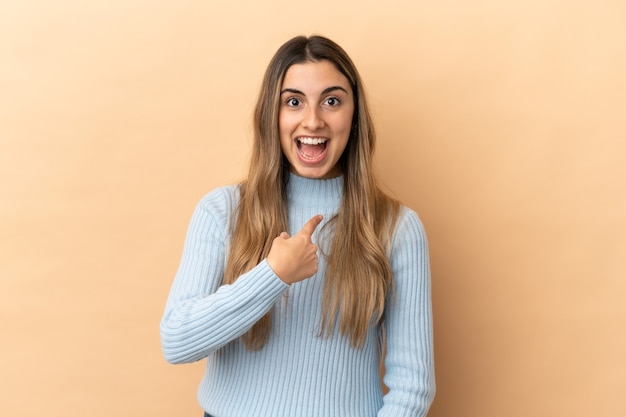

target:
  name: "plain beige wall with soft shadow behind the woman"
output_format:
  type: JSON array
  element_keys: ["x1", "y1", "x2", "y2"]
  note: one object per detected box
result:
[{"x1": 0, "y1": 0, "x2": 626, "y2": 417}]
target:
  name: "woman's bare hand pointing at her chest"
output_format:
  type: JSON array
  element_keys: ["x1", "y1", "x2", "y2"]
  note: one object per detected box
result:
[{"x1": 267, "y1": 214, "x2": 322, "y2": 284}]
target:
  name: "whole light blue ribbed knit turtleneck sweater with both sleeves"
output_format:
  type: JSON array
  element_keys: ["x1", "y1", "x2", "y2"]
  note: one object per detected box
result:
[{"x1": 161, "y1": 174, "x2": 435, "y2": 417}]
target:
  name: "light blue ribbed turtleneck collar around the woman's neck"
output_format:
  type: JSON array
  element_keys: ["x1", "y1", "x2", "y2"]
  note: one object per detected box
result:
[{"x1": 287, "y1": 173, "x2": 343, "y2": 207}]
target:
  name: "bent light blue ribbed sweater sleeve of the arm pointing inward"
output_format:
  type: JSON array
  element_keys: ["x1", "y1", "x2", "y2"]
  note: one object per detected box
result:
[{"x1": 160, "y1": 189, "x2": 289, "y2": 363}]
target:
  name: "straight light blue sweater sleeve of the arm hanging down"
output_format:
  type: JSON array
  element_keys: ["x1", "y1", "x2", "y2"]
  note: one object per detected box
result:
[{"x1": 378, "y1": 208, "x2": 435, "y2": 417}]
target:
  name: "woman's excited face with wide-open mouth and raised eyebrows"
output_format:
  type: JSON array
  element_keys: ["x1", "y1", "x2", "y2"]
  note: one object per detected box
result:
[{"x1": 278, "y1": 60, "x2": 354, "y2": 178}]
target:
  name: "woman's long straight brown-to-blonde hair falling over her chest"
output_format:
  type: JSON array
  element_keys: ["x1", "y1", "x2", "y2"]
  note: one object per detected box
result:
[{"x1": 223, "y1": 36, "x2": 399, "y2": 350}]
